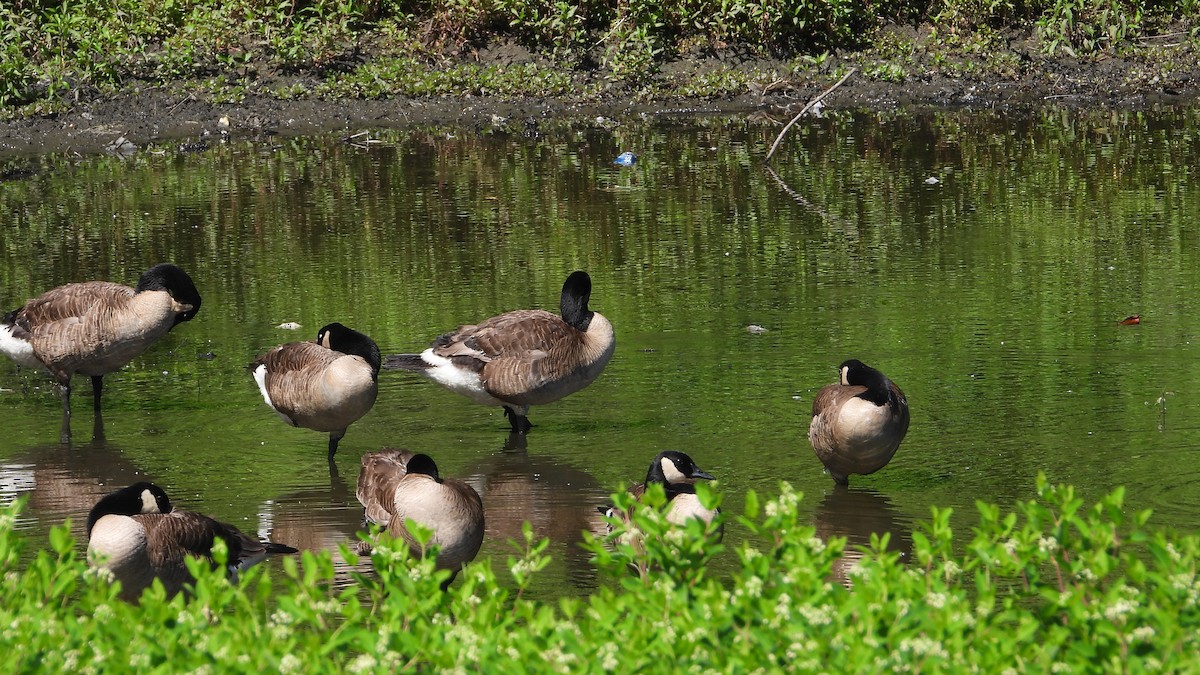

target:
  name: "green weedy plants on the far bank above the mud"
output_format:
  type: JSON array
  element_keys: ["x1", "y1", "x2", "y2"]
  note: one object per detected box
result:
[{"x1": 0, "y1": 0, "x2": 1200, "y2": 117}]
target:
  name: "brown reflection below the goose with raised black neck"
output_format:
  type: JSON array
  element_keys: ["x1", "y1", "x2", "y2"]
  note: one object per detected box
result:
[{"x1": 463, "y1": 432, "x2": 608, "y2": 590}]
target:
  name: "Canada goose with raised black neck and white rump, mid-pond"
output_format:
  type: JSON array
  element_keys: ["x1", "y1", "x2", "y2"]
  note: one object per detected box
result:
[{"x1": 386, "y1": 271, "x2": 617, "y2": 434}]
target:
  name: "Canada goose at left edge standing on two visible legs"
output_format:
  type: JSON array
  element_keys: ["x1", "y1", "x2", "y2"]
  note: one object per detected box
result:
[{"x1": 0, "y1": 263, "x2": 200, "y2": 443}]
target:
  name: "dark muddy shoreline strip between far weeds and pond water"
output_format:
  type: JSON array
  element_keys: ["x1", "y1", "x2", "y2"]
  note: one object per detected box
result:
[{"x1": 0, "y1": 54, "x2": 1200, "y2": 159}]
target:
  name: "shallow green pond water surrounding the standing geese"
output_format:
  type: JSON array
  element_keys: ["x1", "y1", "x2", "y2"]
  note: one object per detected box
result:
[{"x1": 0, "y1": 112, "x2": 1200, "y2": 595}]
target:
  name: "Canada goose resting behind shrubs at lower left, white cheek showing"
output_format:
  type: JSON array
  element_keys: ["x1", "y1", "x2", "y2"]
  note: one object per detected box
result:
[{"x1": 88, "y1": 482, "x2": 296, "y2": 602}]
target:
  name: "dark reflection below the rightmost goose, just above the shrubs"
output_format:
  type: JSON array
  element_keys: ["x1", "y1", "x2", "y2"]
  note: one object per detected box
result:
[{"x1": 814, "y1": 485, "x2": 912, "y2": 589}]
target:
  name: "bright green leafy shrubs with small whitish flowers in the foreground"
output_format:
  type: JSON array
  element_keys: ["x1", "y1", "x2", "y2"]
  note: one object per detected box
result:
[{"x1": 0, "y1": 478, "x2": 1200, "y2": 673}]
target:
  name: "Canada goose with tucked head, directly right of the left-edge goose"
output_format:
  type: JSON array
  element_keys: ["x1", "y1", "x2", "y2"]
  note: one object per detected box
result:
[{"x1": 250, "y1": 323, "x2": 380, "y2": 464}]
